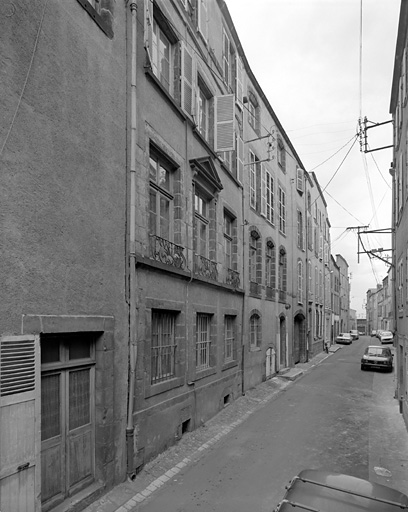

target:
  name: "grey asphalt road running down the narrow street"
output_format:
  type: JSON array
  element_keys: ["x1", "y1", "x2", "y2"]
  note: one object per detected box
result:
[{"x1": 138, "y1": 336, "x2": 395, "y2": 512}]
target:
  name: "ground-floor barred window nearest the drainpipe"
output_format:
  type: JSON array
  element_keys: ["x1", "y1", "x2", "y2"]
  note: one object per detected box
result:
[{"x1": 150, "y1": 310, "x2": 177, "y2": 384}]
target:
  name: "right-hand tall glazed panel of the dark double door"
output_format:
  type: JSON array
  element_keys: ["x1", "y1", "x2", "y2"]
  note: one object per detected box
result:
[{"x1": 69, "y1": 368, "x2": 91, "y2": 430}]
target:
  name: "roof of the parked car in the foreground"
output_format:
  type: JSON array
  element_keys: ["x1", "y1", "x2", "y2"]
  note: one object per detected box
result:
[{"x1": 276, "y1": 469, "x2": 408, "y2": 512}]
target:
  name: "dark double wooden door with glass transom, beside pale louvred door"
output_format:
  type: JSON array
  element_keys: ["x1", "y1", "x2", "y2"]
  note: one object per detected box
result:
[{"x1": 41, "y1": 333, "x2": 95, "y2": 511}]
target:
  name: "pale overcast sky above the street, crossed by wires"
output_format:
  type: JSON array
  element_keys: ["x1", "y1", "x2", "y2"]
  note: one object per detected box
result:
[{"x1": 226, "y1": 0, "x2": 400, "y2": 316}]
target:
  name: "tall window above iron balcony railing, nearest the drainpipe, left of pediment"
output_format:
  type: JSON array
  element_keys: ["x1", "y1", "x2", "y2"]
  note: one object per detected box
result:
[{"x1": 149, "y1": 151, "x2": 173, "y2": 240}]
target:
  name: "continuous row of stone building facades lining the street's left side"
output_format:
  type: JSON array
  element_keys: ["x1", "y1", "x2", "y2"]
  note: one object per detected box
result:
[{"x1": 0, "y1": 0, "x2": 350, "y2": 511}]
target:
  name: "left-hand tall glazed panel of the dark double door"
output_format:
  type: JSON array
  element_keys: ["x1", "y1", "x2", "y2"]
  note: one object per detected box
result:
[{"x1": 41, "y1": 373, "x2": 61, "y2": 441}]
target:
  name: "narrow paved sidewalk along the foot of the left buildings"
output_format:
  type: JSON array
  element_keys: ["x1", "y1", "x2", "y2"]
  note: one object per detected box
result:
[{"x1": 84, "y1": 345, "x2": 334, "y2": 512}]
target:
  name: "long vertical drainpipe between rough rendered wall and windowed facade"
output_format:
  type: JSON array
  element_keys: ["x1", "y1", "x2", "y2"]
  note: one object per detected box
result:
[{"x1": 126, "y1": 2, "x2": 137, "y2": 480}]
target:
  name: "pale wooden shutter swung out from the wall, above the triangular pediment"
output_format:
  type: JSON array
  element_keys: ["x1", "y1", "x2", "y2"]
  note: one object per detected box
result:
[{"x1": 214, "y1": 94, "x2": 235, "y2": 152}]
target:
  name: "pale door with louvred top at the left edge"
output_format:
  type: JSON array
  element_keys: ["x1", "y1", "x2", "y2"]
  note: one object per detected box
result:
[{"x1": 0, "y1": 336, "x2": 41, "y2": 512}]
